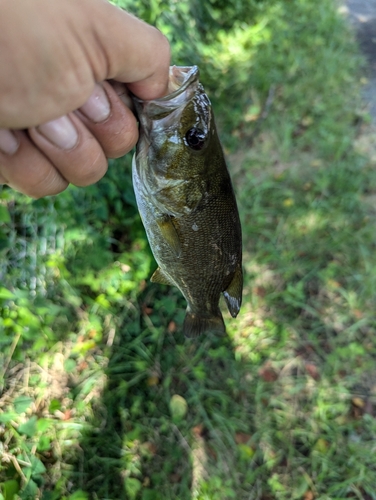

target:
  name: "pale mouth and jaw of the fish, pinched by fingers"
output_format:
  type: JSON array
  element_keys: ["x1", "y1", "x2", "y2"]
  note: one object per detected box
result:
[{"x1": 132, "y1": 66, "x2": 200, "y2": 136}]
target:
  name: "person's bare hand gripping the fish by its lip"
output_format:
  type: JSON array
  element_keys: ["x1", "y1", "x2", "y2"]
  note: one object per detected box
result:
[{"x1": 0, "y1": 0, "x2": 170, "y2": 198}]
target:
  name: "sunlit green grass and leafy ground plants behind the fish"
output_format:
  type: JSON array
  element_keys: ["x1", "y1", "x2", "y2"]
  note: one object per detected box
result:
[{"x1": 0, "y1": 0, "x2": 376, "y2": 500}]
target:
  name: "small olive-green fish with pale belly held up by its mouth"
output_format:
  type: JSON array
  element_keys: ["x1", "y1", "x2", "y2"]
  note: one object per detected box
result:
[{"x1": 132, "y1": 66, "x2": 243, "y2": 338}]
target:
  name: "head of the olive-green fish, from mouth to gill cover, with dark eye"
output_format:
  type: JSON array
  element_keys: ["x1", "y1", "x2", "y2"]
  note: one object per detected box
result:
[{"x1": 133, "y1": 66, "x2": 223, "y2": 215}]
